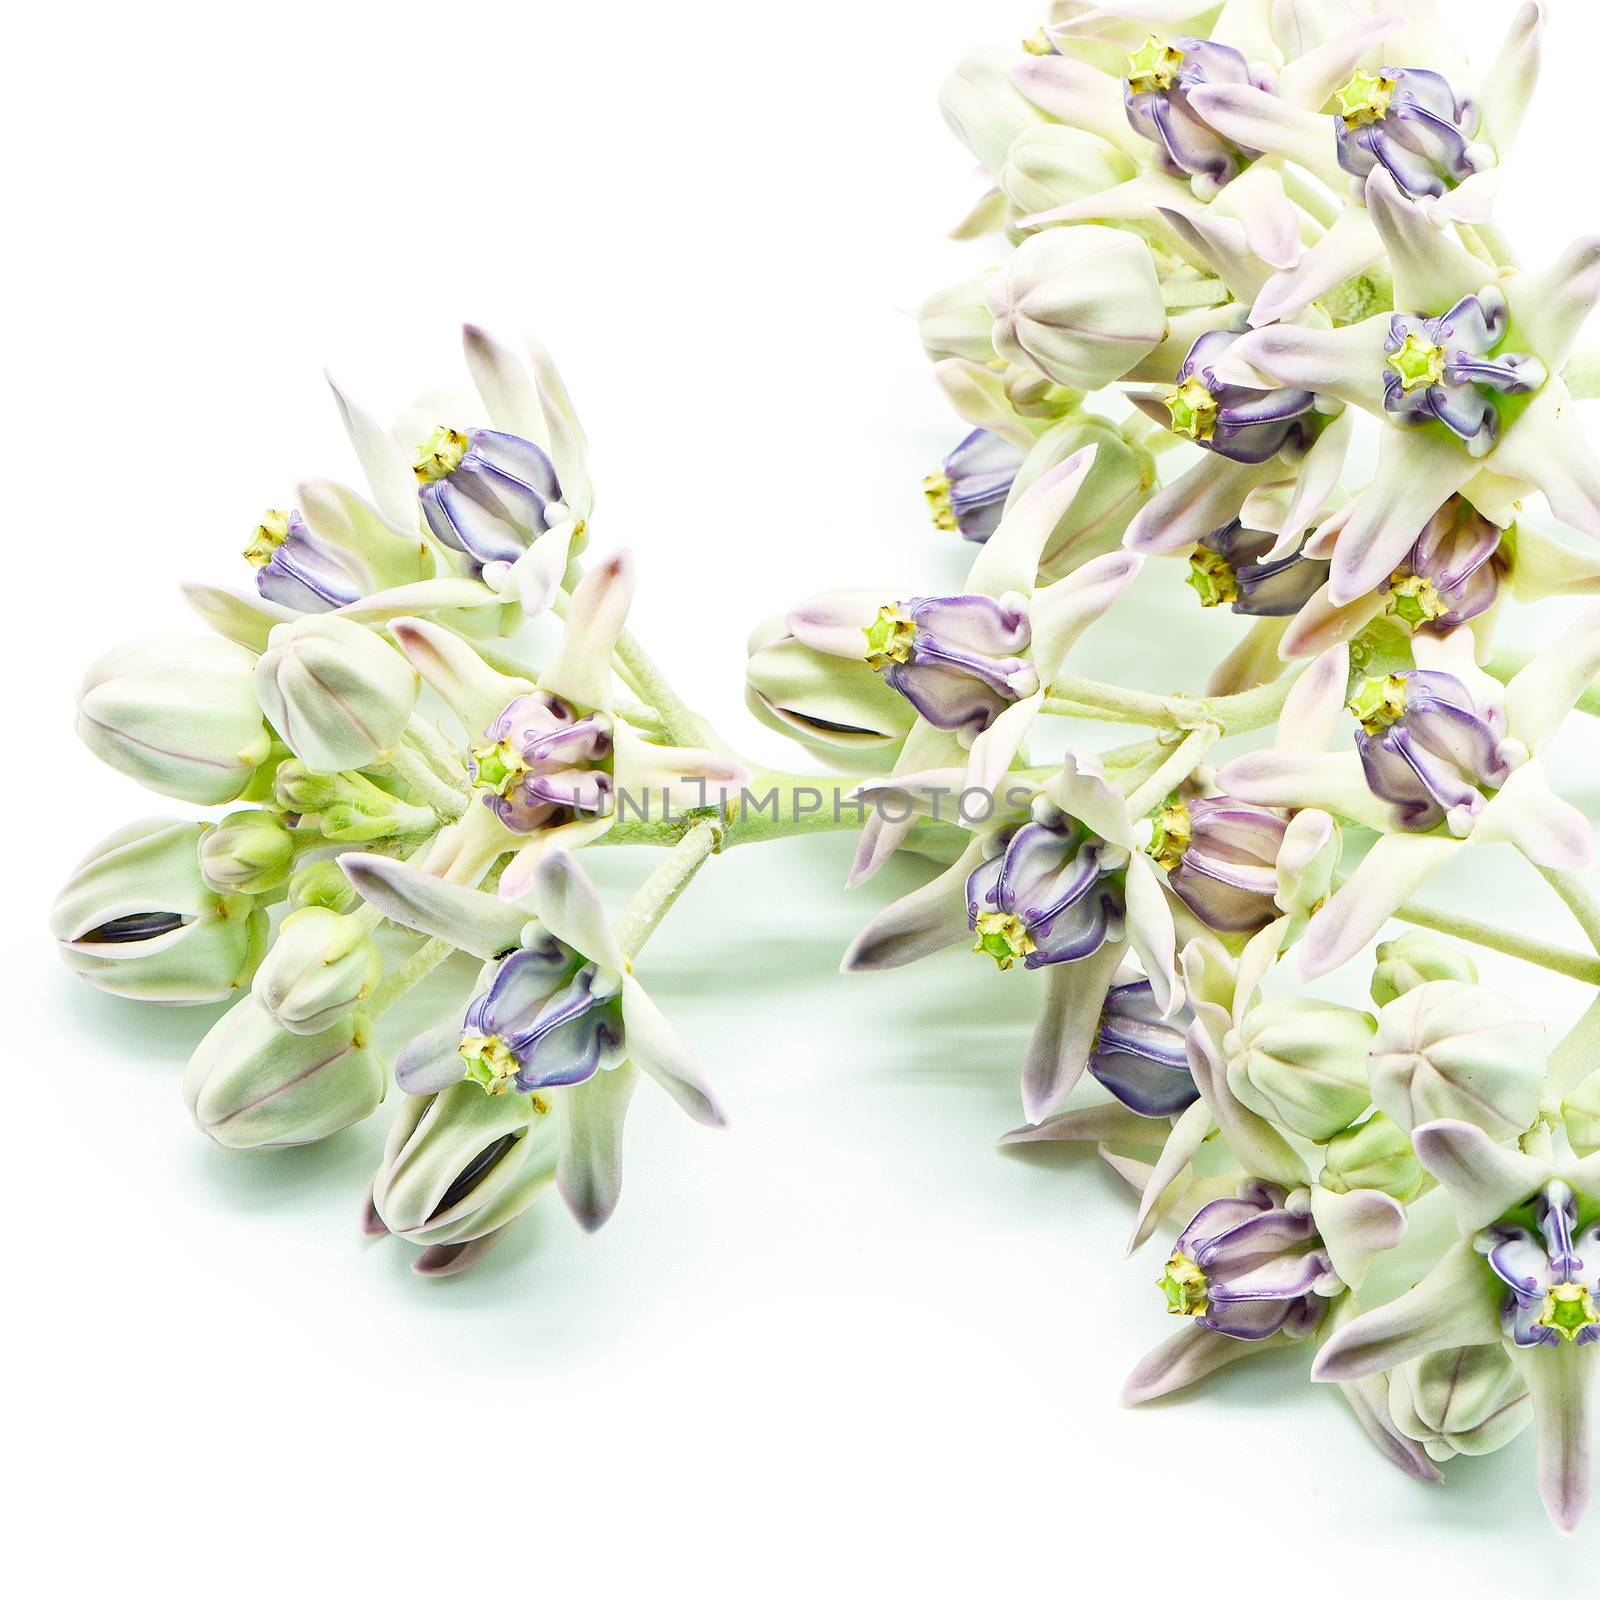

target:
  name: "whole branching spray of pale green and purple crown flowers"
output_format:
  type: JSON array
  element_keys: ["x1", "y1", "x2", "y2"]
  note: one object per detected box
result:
[{"x1": 53, "y1": 0, "x2": 1600, "y2": 1530}]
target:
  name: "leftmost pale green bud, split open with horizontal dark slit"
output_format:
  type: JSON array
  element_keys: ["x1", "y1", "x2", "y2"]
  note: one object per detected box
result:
[{"x1": 50, "y1": 818, "x2": 267, "y2": 1005}]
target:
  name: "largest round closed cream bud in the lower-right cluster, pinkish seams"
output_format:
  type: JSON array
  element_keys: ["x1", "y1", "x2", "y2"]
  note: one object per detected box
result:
[{"x1": 1371, "y1": 979, "x2": 1547, "y2": 1139}]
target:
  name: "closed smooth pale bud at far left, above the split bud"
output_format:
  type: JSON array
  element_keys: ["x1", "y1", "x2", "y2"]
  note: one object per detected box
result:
[{"x1": 78, "y1": 637, "x2": 272, "y2": 805}]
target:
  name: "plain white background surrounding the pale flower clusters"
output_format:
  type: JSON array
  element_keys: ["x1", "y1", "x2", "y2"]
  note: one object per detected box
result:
[{"x1": 9, "y1": 0, "x2": 1600, "y2": 1595}]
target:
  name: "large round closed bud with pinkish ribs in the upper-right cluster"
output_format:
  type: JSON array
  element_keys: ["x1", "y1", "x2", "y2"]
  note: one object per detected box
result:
[{"x1": 986, "y1": 224, "x2": 1166, "y2": 389}]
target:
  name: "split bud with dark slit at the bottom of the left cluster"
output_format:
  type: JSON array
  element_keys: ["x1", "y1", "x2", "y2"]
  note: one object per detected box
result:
[{"x1": 371, "y1": 1083, "x2": 560, "y2": 1248}]
